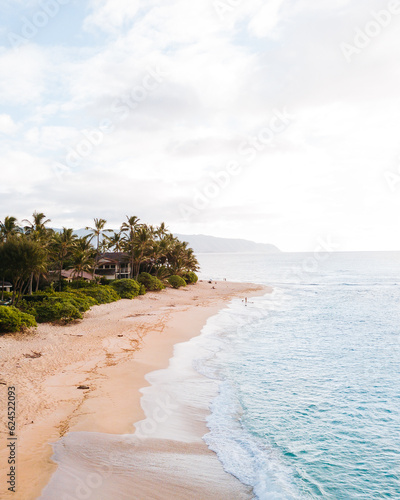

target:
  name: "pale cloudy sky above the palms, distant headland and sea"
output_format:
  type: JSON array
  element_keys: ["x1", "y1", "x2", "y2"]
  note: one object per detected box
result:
[{"x1": 0, "y1": 0, "x2": 400, "y2": 251}]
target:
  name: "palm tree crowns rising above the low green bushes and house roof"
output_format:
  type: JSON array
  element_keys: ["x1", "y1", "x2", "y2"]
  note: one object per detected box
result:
[{"x1": 0, "y1": 211, "x2": 199, "y2": 303}]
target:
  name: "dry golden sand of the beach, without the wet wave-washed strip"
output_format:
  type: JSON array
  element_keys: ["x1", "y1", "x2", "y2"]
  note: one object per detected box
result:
[{"x1": 0, "y1": 282, "x2": 269, "y2": 500}]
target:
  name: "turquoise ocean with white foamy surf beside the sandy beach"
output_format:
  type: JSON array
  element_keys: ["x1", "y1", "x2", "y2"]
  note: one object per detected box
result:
[{"x1": 196, "y1": 253, "x2": 400, "y2": 500}]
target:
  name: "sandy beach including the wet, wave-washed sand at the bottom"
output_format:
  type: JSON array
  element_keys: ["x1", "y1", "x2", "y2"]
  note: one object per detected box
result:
[{"x1": 0, "y1": 282, "x2": 268, "y2": 500}]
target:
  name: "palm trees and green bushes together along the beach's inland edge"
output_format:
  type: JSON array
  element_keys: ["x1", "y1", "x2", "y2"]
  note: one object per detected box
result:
[{"x1": 0, "y1": 212, "x2": 199, "y2": 333}]
